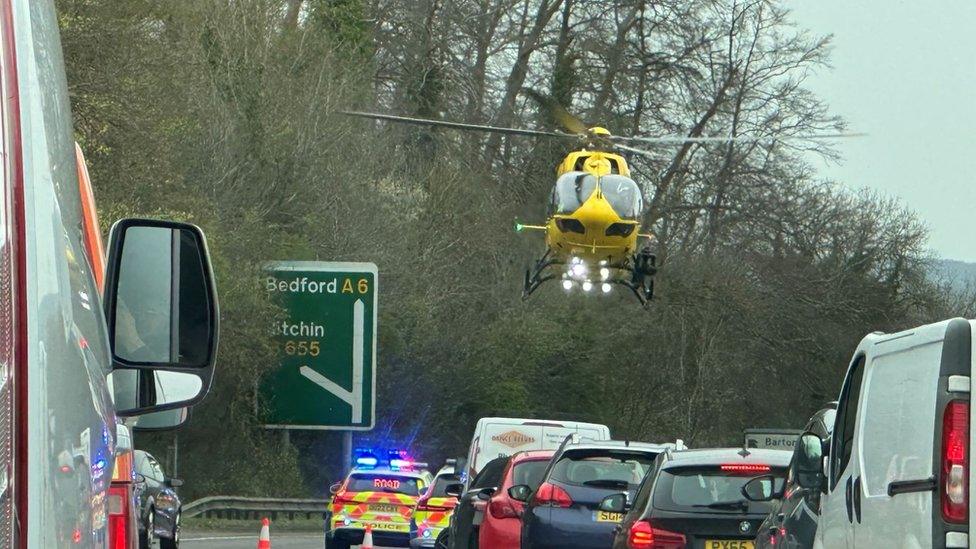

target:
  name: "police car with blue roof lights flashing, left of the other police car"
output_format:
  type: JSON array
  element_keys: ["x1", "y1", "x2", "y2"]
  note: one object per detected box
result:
[{"x1": 325, "y1": 451, "x2": 434, "y2": 549}]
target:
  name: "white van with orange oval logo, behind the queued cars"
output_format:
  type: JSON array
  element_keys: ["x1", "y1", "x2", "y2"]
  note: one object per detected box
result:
[{"x1": 466, "y1": 417, "x2": 610, "y2": 478}]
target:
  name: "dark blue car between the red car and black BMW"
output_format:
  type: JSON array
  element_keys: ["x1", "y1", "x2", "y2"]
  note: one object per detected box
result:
[{"x1": 509, "y1": 441, "x2": 674, "y2": 549}]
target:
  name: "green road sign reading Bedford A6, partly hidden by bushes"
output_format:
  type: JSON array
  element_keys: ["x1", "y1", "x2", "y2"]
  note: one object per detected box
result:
[{"x1": 259, "y1": 261, "x2": 377, "y2": 431}]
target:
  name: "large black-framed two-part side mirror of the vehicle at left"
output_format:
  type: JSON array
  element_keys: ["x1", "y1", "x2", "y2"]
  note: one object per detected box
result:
[{"x1": 104, "y1": 219, "x2": 219, "y2": 416}]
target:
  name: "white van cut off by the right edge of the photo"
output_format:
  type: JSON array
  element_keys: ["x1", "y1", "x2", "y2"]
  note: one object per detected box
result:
[{"x1": 815, "y1": 319, "x2": 976, "y2": 549}]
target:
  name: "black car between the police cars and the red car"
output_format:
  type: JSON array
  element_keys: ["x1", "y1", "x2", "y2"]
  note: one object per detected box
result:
[{"x1": 435, "y1": 456, "x2": 509, "y2": 549}]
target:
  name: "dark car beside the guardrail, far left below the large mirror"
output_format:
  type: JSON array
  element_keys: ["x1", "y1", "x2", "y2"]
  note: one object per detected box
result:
[{"x1": 133, "y1": 450, "x2": 183, "y2": 549}]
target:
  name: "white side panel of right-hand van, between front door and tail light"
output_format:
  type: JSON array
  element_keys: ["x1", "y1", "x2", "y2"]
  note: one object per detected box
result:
[{"x1": 850, "y1": 324, "x2": 945, "y2": 548}]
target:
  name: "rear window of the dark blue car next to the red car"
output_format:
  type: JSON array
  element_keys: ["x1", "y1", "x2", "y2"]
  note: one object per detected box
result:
[{"x1": 549, "y1": 449, "x2": 657, "y2": 490}]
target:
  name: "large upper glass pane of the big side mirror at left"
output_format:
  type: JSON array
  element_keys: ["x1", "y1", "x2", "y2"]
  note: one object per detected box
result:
[{"x1": 114, "y1": 226, "x2": 213, "y2": 367}]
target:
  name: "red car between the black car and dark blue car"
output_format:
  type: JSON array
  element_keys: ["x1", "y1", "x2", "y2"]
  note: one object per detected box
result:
[{"x1": 478, "y1": 450, "x2": 555, "y2": 547}]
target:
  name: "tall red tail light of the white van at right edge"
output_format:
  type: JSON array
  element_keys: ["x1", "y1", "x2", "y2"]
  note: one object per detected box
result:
[{"x1": 942, "y1": 400, "x2": 969, "y2": 523}]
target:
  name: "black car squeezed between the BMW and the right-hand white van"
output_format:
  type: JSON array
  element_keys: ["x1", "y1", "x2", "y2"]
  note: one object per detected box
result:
[{"x1": 756, "y1": 402, "x2": 837, "y2": 549}]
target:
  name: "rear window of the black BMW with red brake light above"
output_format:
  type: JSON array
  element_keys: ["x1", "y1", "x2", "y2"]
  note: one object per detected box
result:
[{"x1": 654, "y1": 466, "x2": 786, "y2": 514}]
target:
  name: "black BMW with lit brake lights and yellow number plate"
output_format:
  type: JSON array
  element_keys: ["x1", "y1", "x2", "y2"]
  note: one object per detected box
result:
[{"x1": 600, "y1": 448, "x2": 792, "y2": 549}]
